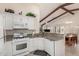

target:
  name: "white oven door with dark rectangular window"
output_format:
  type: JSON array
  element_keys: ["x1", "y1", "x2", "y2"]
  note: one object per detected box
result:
[{"x1": 13, "y1": 41, "x2": 28, "y2": 55}]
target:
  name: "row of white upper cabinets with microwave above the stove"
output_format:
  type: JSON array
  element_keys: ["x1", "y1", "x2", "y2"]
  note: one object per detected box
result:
[{"x1": 2, "y1": 12, "x2": 37, "y2": 30}]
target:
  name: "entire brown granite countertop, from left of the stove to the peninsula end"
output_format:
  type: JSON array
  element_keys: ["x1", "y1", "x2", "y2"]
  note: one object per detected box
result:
[{"x1": 6, "y1": 33, "x2": 64, "y2": 41}]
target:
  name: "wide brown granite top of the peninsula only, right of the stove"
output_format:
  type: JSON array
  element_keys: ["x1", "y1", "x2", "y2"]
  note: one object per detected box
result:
[{"x1": 32, "y1": 33, "x2": 64, "y2": 41}]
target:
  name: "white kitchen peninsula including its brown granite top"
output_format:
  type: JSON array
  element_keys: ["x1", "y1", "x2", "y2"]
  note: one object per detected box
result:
[{"x1": 30, "y1": 32, "x2": 65, "y2": 56}]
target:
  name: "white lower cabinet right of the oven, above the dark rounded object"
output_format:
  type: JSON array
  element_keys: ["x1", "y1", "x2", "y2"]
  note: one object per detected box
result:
[{"x1": 29, "y1": 38, "x2": 44, "y2": 51}]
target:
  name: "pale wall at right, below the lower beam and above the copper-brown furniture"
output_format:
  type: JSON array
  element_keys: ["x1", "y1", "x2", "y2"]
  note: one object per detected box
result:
[{"x1": 51, "y1": 13, "x2": 79, "y2": 33}]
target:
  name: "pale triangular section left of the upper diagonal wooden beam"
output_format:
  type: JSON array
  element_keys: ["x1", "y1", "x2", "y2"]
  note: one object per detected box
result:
[{"x1": 38, "y1": 3, "x2": 62, "y2": 20}]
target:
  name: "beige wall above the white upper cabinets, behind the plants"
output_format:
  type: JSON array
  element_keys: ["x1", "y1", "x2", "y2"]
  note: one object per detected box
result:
[{"x1": 0, "y1": 3, "x2": 38, "y2": 15}]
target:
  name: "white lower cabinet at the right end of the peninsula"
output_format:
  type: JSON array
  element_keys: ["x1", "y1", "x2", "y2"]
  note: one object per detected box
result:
[{"x1": 44, "y1": 39, "x2": 65, "y2": 56}]
